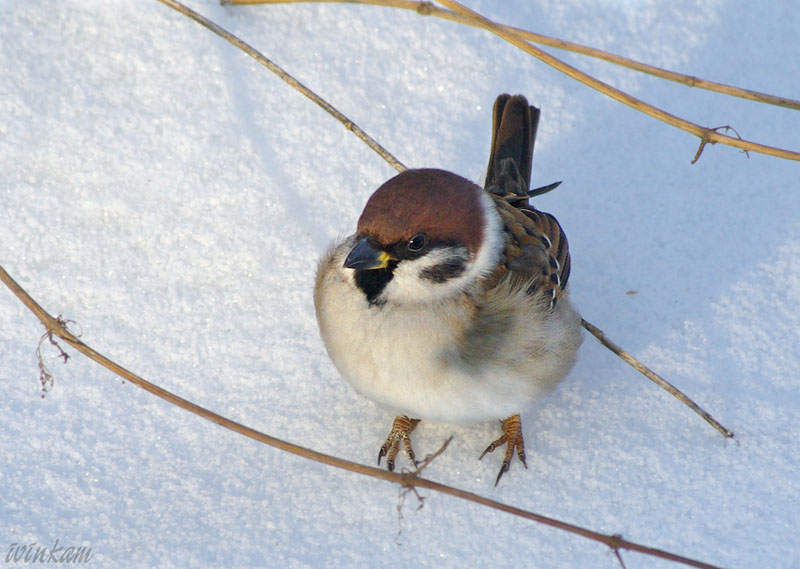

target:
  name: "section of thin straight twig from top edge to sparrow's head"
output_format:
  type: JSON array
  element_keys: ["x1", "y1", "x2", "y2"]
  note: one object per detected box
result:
[{"x1": 158, "y1": 0, "x2": 406, "y2": 170}]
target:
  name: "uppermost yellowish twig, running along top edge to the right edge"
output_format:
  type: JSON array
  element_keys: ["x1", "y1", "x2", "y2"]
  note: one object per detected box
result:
[{"x1": 222, "y1": 0, "x2": 800, "y2": 110}]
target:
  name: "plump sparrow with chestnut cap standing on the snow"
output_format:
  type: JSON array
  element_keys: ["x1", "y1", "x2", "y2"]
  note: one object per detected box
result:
[{"x1": 314, "y1": 95, "x2": 582, "y2": 486}]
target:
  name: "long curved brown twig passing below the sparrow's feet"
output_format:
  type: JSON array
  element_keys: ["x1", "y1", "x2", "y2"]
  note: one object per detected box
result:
[{"x1": 0, "y1": 266, "x2": 720, "y2": 569}]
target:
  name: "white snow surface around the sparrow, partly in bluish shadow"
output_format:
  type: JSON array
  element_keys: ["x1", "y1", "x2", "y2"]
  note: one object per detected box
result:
[{"x1": 0, "y1": 0, "x2": 800, "y2": 568}]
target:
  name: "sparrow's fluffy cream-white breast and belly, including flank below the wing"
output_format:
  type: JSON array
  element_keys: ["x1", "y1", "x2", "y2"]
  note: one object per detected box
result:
[{"x1": 315, "y1": 242, "x2": 579, "y2": 423}]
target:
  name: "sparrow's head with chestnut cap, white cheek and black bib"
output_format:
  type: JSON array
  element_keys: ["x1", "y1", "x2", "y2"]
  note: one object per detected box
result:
[{"x1": 344, "y1": 169, "x2": 503, "y2": 304}]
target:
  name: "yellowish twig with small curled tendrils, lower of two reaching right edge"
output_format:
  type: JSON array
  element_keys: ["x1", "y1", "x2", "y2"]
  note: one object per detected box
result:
[{"x1": 438, "y1": 0, "x2": 800, "y2": 161}]
